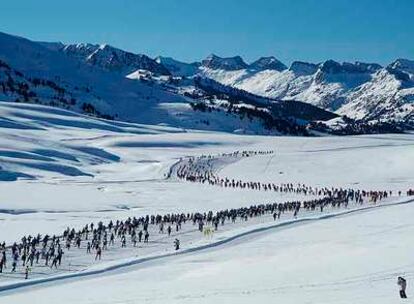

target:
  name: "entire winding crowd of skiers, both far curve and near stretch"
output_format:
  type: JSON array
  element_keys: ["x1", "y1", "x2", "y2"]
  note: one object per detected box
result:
[{"x1": 0, "y1": 151, "x2": 414, "y2": 279}]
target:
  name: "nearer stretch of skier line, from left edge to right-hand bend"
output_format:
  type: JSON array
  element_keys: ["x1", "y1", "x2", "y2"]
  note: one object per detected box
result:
[{"x1": 0, "y1": 186, "x2": 404, "y2": 278}]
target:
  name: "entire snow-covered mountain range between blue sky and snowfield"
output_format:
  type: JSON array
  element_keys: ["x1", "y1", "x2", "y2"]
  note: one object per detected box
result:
[{"x1": 0, "y1": 33, "x2": 414, "y2": 134}]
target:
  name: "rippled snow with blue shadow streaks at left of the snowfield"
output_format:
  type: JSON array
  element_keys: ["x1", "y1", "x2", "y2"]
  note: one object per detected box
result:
[{"x1": 0, "y1": 102, "x2": 180, "y2": 180}]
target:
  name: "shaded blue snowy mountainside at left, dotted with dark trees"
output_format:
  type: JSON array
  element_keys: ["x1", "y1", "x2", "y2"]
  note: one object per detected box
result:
[{"x1": 0, "y1": 33, "x2": 308, "y2": 134}]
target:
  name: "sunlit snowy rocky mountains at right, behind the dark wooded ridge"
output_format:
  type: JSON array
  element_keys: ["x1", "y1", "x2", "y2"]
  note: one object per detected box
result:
[{"x1": 196, "y1": 55, "x2": 414, "y2": 121}]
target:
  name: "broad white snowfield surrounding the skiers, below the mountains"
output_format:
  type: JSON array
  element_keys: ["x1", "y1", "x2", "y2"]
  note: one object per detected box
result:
[{"x1": 0, "y1": 102, "x2": 414, "y2": 304}]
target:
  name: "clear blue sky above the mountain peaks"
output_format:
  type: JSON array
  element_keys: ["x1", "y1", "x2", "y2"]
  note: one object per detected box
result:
[{"x1": 0, "y1": 0, "x2": 414, "y2": 64}]
